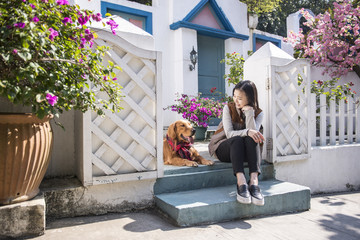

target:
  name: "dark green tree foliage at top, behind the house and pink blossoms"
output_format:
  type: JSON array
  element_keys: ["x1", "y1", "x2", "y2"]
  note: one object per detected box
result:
[{"x1": 257, "y1": 0, "x2": 335, "y2": 37}]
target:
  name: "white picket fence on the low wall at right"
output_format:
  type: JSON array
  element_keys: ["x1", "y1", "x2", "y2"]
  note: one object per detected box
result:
[{"x1": 310, "y1": 93, "x2": 360, "y2": 146}]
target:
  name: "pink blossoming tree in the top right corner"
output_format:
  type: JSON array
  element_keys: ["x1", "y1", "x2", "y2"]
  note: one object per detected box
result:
[{"x1": 287, "y1": 0, "x2": 360, "y2": 77}]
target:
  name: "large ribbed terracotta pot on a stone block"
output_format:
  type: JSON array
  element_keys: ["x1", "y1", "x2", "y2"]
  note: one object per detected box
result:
[{"x1": 0, "y1": 113, "x2": 53, "y2": 205}]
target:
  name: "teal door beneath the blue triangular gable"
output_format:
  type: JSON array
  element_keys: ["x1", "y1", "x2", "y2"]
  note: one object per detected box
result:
[{"x1": 197, "y1": 35, "x2": 225, "y2": 125}]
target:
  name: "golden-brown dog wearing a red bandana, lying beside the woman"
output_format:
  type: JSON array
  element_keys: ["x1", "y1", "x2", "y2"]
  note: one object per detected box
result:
[{"x1": 163, "y1": 120, "x2": 214, "y2": 167}]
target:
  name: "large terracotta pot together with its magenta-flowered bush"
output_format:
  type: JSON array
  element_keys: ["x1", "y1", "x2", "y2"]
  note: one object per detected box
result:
[{"x1": 0, "y1": 0, "x2": 121, "y2": 204}]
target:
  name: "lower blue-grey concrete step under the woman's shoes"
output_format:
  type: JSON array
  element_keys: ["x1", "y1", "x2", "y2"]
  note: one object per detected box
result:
[{"x1": 155, "y1": 180, "x2": 310, "y2": 226}]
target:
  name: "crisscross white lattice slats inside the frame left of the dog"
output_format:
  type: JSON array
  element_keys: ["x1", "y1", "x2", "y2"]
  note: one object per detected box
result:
[{"x1": 90, "y1": 39, "x2": 157, "y2": 183}]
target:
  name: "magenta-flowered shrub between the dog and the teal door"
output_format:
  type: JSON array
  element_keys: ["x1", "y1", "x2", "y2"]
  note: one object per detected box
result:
[{"x1": 165, "y1": 93, "x2": 224, "y2": 127}]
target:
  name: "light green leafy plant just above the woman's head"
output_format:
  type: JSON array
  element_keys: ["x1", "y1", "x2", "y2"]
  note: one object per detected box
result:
[{"x1": 220, "y1": 52, "x2": 245, "y2": 86}]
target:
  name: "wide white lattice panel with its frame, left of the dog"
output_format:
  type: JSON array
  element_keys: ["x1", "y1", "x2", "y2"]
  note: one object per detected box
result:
[{"x1": 84, "y1": 33, "x2": 162, "y2": 185}]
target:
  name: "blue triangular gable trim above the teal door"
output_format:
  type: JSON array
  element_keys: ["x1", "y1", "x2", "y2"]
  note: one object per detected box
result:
[{"x1": 170, "y1": 0, "x2": 249, "y2": 40}]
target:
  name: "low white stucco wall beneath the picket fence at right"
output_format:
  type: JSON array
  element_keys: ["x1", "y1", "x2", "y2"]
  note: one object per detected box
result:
[{"x1": 274, "y1": 144, "x2": 360, "y2": 193}]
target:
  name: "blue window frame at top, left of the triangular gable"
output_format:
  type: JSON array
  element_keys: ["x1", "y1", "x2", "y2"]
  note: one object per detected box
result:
[{"x1": 101, "y1": 2, "x2": 152, "y2": 34}]
